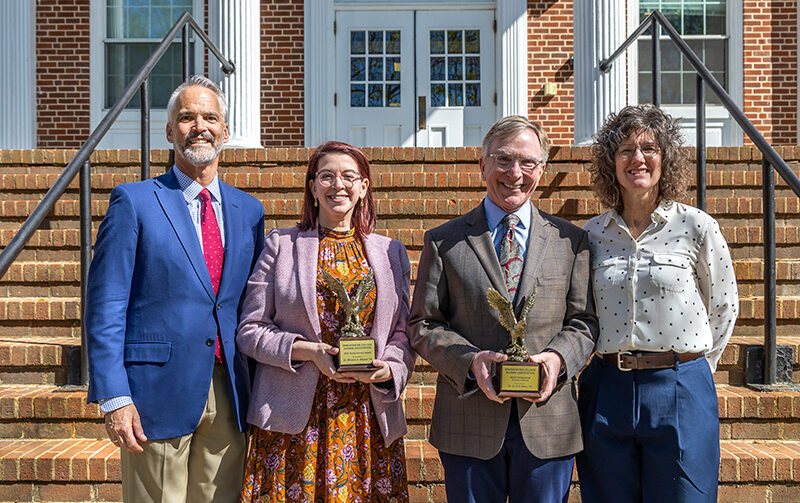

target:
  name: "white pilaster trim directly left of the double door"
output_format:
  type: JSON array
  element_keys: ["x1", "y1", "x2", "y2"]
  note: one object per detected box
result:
[{"x1": 303, "y1": 0, "x2": 334, "y2": 147}]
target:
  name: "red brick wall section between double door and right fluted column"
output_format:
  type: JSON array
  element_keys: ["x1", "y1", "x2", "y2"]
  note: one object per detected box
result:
[{"x1": 528, "y1": 0, "x2": 575, "y2": 145}]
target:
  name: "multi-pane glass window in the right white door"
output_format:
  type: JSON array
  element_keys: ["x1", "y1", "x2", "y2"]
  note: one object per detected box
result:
[{"x1": 428, "y1": 30, "x2": 481, "y2": 107}]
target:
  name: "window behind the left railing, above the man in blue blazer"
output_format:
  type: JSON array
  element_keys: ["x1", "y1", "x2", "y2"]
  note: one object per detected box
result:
[{"x1": 103, "y1": 0, "x2": 194, "y2": 108}]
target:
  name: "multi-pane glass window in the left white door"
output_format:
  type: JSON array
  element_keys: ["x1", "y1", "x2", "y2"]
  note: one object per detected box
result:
[{"x1": 350, "y1": 30, "x2": 400, "y2": 107}]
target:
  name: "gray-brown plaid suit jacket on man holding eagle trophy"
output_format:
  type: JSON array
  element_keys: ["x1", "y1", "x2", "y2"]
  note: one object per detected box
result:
[{"x1": 408, "y1": 204, "x2": 598, "y2": 459}]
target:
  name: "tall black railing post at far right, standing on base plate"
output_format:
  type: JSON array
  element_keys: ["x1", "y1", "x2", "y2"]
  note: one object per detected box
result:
[{"x1": 761, "y1": 159, "x2": 778, "y2": 384}]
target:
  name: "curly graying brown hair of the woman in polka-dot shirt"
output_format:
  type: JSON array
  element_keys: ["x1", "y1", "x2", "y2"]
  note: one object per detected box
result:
[{"x1": 589, "y1": 105, "x2": 690, "y2": 213}]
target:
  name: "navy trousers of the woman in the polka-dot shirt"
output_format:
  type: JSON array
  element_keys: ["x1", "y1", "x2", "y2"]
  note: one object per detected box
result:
[{"x1": 577, "y1": 357, "x2": 719, "y2": 503}]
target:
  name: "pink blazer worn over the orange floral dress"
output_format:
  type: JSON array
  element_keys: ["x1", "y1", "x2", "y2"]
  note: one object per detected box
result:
[{"x1": 236, "y1": 227, "x2": 415, "y2": 446}]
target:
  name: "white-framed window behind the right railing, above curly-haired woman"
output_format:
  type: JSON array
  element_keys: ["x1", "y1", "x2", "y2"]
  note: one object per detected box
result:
[{"x1": 638, "y1": 0, "x2": 729, "y2": 105}]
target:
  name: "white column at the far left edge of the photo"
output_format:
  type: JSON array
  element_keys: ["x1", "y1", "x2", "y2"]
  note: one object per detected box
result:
[{"x1": 0, "y1": 2, "x2": 36, "y2": 148}]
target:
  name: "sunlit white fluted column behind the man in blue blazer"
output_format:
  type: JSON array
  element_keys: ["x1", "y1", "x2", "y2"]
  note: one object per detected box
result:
[{"x1": 208, "y1": 0, "x2": 261, "y2": 147}]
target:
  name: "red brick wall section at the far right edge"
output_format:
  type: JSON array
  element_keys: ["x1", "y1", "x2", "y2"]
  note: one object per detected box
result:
[{"x1": 743, "y1": 0, "x2": 797, "y2": 144}]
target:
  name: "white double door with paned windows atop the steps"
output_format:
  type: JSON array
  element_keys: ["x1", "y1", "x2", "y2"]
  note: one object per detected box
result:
[{"x1": 335, "y1": 10, "x2": 497, "y2": 147}]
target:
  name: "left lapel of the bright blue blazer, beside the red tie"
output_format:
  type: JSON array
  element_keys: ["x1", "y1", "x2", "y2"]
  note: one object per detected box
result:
[{"x1": 155, "y1": 171, "x2": 216, "y2": 300}]
